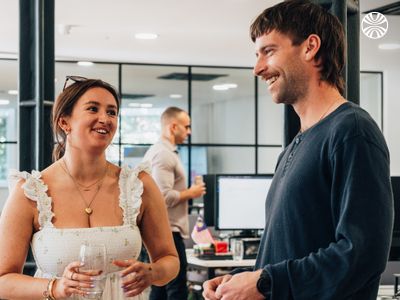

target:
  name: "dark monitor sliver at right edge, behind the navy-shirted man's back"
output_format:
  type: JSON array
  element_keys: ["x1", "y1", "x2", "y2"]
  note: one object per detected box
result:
[{"x1": 389, "y1": 176, "x2": 400, "y2": 261}]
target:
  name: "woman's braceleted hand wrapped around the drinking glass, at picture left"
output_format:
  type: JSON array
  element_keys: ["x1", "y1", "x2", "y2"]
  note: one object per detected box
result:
[{"x1": 53, "y1": 261, "x2": 95, "y2": 299}]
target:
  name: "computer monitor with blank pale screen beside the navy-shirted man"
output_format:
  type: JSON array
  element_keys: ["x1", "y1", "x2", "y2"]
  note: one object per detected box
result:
[{"x1": 215, "y1": 174, "x2": 272, "y2": 230}]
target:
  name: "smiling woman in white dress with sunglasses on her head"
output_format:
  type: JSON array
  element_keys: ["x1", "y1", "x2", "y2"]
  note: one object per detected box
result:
[{"x1": 0, "y1": 76, "x2": 179, "y2": 300}]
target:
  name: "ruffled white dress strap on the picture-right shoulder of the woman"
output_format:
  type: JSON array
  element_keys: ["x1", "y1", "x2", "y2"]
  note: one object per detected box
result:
[{"x1": 119, "y1": 162, "x2": 151, "y2": 225}]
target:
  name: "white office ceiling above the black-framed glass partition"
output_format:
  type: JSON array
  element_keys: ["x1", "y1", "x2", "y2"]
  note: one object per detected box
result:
[{"x1": 0, "y1": 0, "x2": 400, "y2": 66}]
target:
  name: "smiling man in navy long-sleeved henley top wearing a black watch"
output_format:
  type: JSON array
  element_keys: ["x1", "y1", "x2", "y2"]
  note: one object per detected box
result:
[{"x1": 203, "y1": 0, "x2": 393, "y2": 300}]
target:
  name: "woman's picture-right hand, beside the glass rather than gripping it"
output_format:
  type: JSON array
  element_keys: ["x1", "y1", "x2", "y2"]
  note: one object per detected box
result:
[{"x1": 113, "y1": 259, "x2": 153, "y2": 297}]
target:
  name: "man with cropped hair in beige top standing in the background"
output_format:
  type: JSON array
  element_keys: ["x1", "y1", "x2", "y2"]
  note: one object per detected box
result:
[{"x1": 143, "y1": 107, "x2": 205, "y2": 300}]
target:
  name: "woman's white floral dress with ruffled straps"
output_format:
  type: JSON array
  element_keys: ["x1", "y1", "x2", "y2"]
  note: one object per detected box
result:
[{"x1": 10, "y1": 164, "x2": 150, "y2": 300}]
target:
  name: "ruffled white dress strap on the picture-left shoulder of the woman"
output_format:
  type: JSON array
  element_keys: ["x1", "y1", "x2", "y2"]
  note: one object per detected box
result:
[{"x1": 8, "y1": 170, "x2": 54, "y2": 229}]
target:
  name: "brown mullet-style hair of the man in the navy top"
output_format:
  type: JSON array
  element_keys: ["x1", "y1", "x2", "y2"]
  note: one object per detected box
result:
[{"x1": 250, "y1": 0, "x2": 345, "y2": 95}]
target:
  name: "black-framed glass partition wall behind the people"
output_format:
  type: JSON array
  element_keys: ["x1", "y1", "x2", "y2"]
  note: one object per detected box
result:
[{"x1": 0, "y1": 59, "x2": 383, "y2": 191}]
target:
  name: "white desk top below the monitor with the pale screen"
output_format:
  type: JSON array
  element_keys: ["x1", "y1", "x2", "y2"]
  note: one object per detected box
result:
[{"x1": 186, "y1": 249, "x2": 256, "y2": 279}]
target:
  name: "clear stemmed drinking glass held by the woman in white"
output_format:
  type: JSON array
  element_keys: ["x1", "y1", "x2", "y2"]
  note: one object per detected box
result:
[{"x1": 79, "y1": 244, "x2": 107, "y2": 299}]
